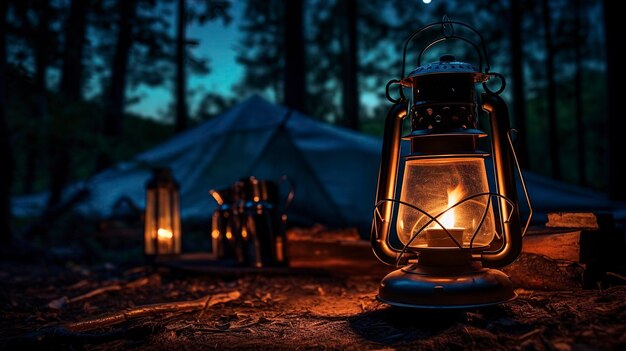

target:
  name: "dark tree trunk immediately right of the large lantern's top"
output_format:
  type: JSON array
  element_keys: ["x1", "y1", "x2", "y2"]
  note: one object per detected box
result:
[{"x1": 510, "y1": 0, "x2": 530, "y2": 168}]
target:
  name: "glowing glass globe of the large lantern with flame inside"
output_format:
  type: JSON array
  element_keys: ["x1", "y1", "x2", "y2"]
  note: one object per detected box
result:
[{"x1": 396, "y1": 157, "x2": 496, "y2": 249}]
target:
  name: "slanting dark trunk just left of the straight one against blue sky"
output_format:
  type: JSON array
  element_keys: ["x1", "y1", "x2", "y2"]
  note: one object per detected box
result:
[{"x1": 96, "y1": 0, "x2": 137, "y2": 170}]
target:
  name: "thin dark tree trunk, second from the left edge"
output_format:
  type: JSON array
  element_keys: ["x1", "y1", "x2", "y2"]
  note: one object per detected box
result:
[{"x1": 24, "y1": 0, "x2": 50, "y2": 194}]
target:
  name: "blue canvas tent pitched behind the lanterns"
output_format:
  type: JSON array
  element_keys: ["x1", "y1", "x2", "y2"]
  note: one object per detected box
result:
[{"x1": 13, "y1": 96, "x2": 626, "y2": 234}]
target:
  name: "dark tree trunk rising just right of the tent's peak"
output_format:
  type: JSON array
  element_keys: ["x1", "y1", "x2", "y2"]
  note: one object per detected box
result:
[{"x1": 284, "y1": 0, "x2": 306, "y2": 112}]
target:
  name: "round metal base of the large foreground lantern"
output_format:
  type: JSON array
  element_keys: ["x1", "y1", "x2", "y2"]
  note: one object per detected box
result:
[{"x1": 378, "y1": 255, "x2": 517, "y2": 309}]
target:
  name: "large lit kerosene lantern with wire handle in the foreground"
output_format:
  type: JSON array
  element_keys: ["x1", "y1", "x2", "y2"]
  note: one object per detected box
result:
[{"x1": 371, "y1": 20, "x2": 532, "y2": 308}]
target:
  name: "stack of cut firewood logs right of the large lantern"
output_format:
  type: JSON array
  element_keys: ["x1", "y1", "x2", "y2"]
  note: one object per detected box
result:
[{"x1": 505, "y1": 221, "x2": 626, "y2": 290}]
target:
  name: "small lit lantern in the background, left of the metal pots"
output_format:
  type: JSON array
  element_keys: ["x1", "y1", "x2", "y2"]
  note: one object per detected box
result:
[{"x1": 144, "y1": 168, "x2": 181, "y2": 256}]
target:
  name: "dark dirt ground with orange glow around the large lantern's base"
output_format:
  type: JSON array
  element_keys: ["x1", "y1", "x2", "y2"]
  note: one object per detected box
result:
[{"x1": 0, "y1": 253, "x2": 626, "y2": 350}]
